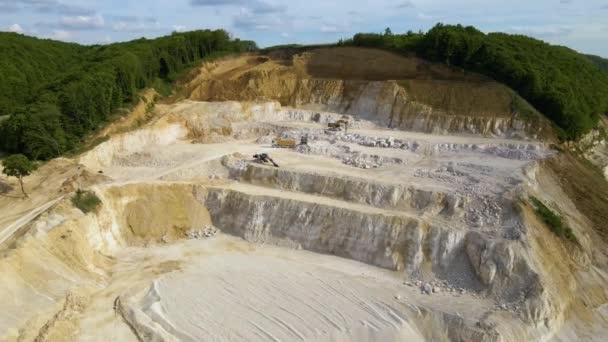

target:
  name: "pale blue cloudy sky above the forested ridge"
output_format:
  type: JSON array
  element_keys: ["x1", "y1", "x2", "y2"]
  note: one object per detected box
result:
[{"x1": 0, "y1": 0, "x2": 608, "y2": 57}]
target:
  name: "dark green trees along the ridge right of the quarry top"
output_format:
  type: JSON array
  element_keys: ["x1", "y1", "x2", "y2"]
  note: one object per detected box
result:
[{"x1": 341, "y1": 24, "x2": 608, "y2": 139}]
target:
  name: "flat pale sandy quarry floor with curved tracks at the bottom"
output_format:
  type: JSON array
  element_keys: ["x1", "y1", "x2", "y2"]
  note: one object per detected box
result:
[{"x1": 109, "y1": 236, "x2": 491, "y2": 341}]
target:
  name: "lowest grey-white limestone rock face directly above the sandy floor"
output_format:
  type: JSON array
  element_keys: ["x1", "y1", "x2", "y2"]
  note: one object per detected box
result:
[{"x1": 204, "y1": 188, "x2": 422, "y2": 270}]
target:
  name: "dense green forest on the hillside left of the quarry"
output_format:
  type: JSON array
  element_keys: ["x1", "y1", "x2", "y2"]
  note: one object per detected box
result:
[{"x1": 0, "y1": 30, "x2": 257, "y2": 160}]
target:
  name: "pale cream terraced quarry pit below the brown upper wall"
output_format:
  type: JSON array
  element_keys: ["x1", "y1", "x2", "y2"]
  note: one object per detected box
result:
[{"x1": 0, "y1": 48, "x2": 608, "y2": 341}]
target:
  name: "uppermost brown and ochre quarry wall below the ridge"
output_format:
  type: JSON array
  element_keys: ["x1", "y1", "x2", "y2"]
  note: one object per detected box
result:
[{"x1": 189, "y1": 48, "x2": 551, "y2": 136}]
